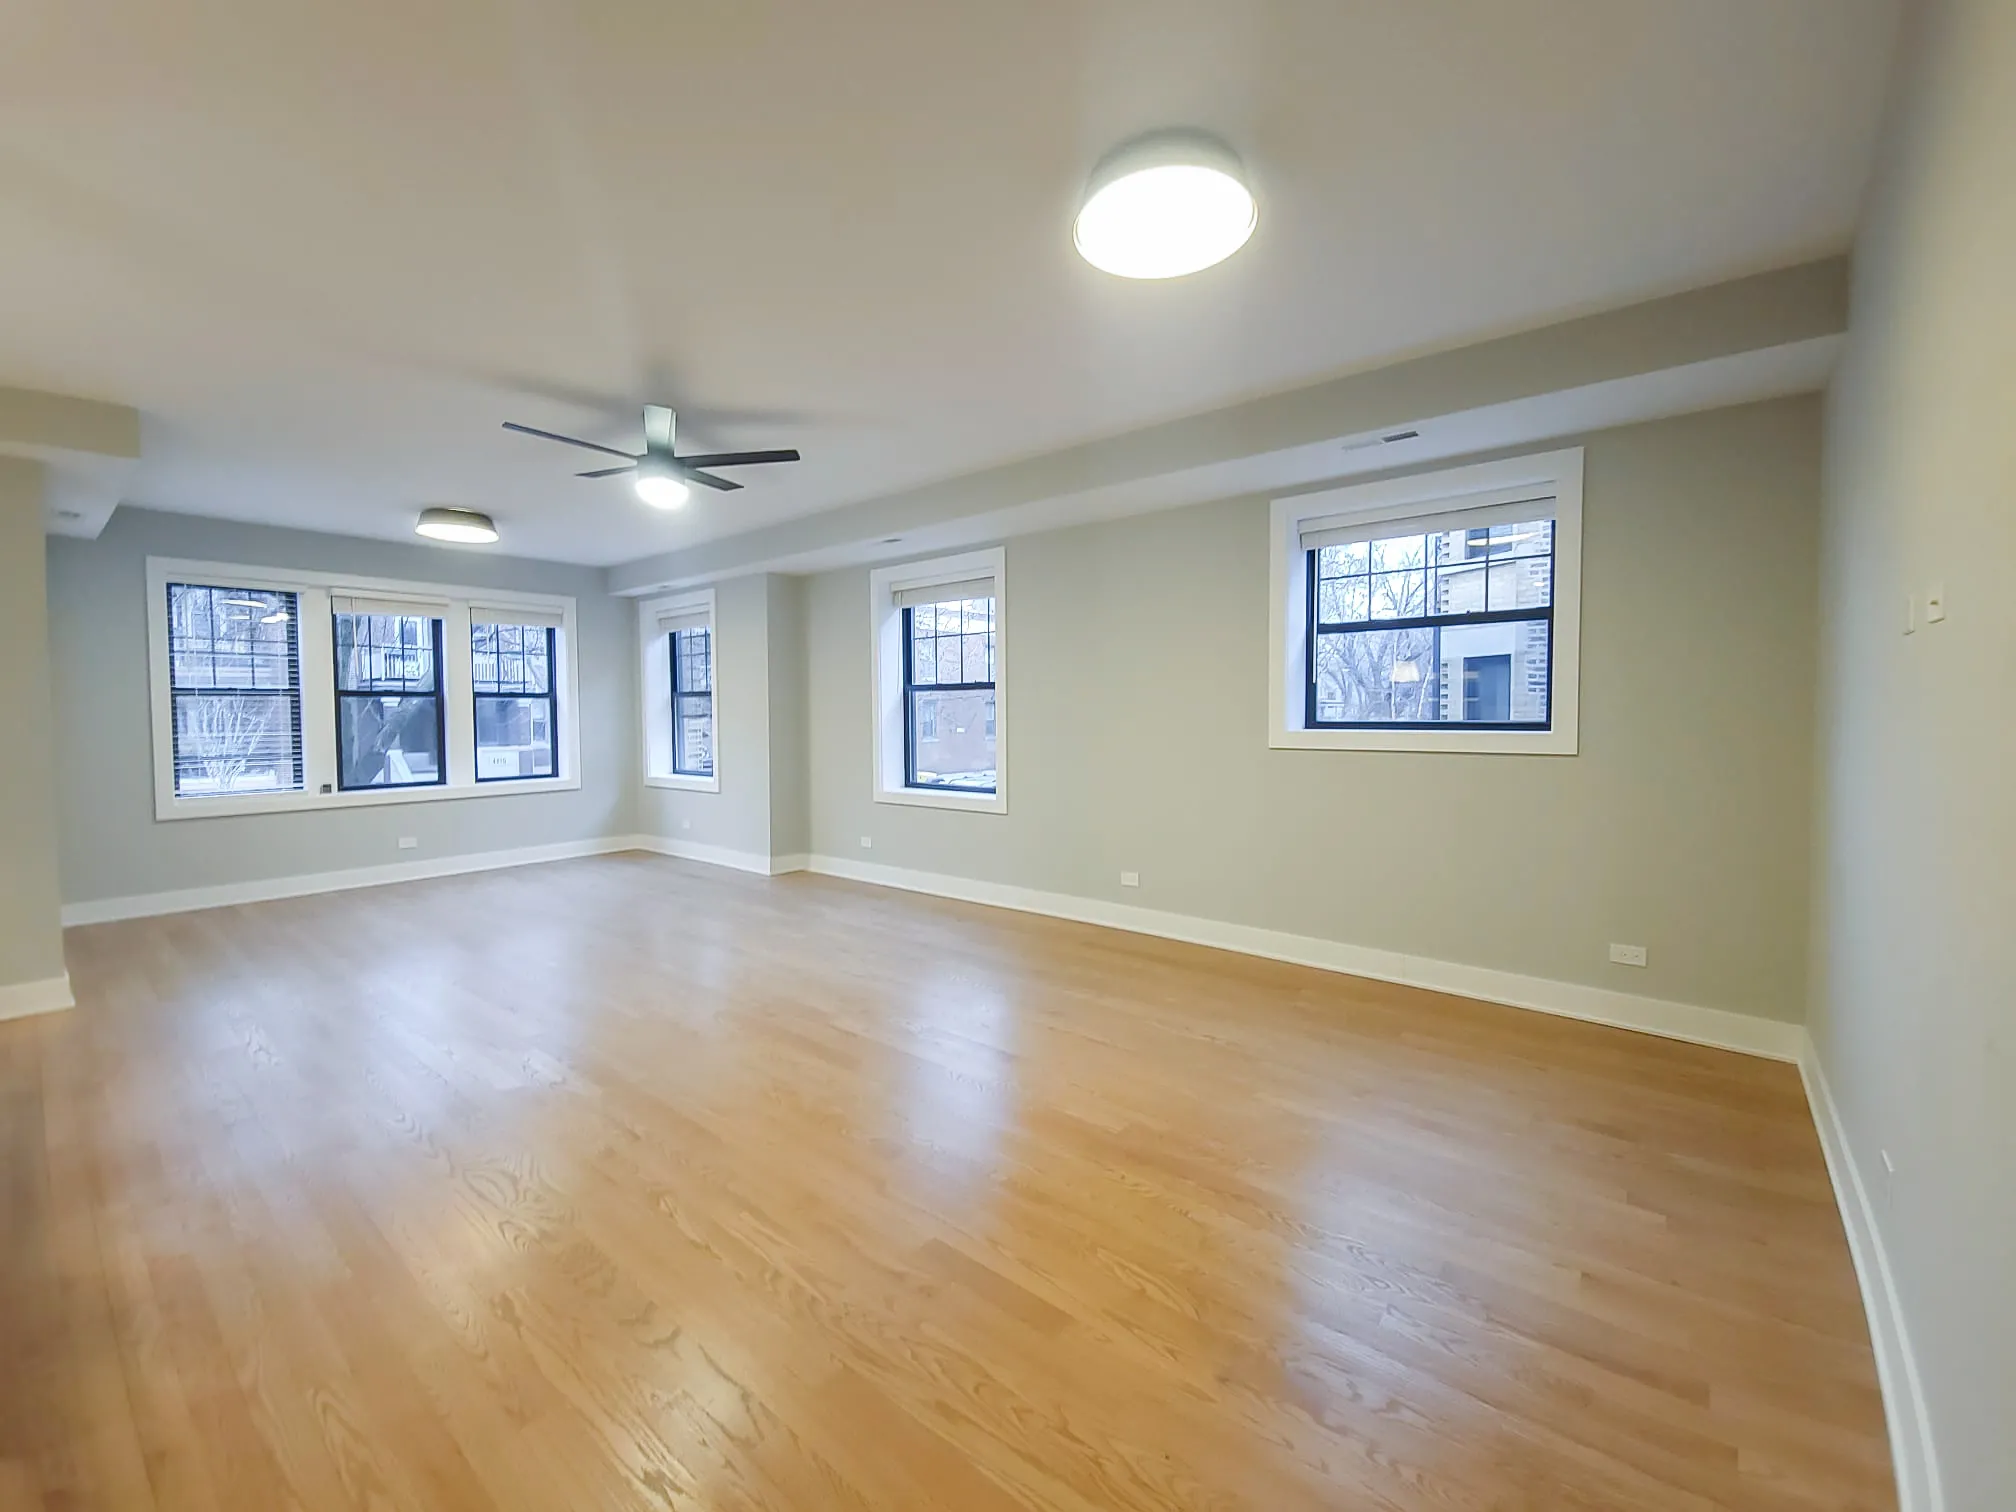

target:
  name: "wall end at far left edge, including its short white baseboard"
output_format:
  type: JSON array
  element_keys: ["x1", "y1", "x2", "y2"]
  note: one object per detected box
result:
[{"x1": 0, "y1": 456, "x2": 71, "y2": 1018}]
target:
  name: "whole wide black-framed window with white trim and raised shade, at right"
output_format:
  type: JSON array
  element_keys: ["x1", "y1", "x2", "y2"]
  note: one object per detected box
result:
[{"x1": 1270, "y1": 452, "x2": 1581, "y2": 754}]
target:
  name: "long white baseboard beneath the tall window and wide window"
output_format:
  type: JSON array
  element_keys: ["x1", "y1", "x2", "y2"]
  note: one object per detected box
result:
[{"x1": 810, "y1": 855, "x2": 1804, "y2": 1060}]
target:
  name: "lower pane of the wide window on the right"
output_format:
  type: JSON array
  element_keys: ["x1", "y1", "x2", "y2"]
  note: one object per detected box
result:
[{"x1": 1316, "y1": 619, "x2": 1550, "y2": 726}]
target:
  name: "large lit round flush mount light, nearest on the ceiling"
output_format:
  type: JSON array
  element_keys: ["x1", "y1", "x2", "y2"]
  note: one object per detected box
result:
[{"x1": 1073, "y1": 131, "x2": 1258, "y2": 278}]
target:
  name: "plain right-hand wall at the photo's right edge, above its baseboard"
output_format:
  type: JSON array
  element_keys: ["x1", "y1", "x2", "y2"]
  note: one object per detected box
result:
[{"x1": 1810, "y1": 0, "x2": 2016, "y2": 1512}]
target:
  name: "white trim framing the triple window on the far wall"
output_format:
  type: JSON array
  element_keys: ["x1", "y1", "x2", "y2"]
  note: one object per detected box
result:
[{"x1": 147, "y1": 556, "x2": 581, "y2": 821}]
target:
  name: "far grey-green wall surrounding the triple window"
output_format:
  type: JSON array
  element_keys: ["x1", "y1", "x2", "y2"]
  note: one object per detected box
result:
[{"x1": 47, "y1": 508, "x2": 639, "y2": 903}]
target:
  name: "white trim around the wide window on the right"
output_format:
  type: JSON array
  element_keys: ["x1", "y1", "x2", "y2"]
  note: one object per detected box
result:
[{"x1": 1268, "y1": 448, "x2": 1583, "y2": 756}]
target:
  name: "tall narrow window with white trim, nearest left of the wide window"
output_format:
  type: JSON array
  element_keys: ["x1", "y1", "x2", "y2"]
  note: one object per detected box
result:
[{"x1": 869, "y1": 548, "x2": 1008, "y2": 812}]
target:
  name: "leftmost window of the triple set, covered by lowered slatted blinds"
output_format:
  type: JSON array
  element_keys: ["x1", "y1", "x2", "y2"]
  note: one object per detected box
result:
[{"x1": 167, "y1": 583, "x2": 302, "y2": 798}]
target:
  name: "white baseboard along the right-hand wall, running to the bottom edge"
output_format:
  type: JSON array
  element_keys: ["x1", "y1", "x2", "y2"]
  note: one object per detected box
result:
[{"x1": 1798, "y1": 1034, "x2": 1945, "y2": 1512}]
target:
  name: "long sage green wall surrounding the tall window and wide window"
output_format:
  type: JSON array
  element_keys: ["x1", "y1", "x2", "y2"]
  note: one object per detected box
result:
[{"x1": 806, "y1": 395, "x2": 1820, "y2": 1020}]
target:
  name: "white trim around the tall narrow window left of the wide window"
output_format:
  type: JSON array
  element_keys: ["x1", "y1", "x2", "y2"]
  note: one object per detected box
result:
[{"x1": 869, "y1": 546, "x2": 1008, "y2": 814}]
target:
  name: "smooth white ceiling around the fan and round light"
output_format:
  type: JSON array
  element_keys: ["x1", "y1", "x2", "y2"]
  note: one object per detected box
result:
[{"x1": 0, "y1": 0, "x2": 1897, "y2": 562}]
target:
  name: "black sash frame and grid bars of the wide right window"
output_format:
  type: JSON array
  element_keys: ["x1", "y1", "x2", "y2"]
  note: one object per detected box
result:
[{"x1": 1302, "y1": 516, "x2": 1560, "y2": 732}]
